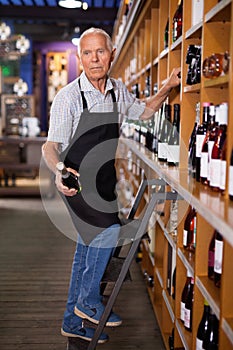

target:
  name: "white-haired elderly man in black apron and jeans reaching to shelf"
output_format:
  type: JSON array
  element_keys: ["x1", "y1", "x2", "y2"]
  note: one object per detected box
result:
[{"x1": 43, "y1": 28, "x2": 180, "y2": 343}]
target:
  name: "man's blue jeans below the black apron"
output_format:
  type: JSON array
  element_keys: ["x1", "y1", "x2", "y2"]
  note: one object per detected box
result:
[{"x1": 63, "y1": 224, "x2": 120, "y2": 330}]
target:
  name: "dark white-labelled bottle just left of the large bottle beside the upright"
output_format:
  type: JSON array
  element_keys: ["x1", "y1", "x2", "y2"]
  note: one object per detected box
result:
[{"x1": 158, "y1": 104, "x2": 171, "y2": 162}]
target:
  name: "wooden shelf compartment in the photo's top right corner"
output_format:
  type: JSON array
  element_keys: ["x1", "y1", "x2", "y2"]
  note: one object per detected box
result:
[{"x1": 205, "y1": 0, "x2": 231, "y2": 22}]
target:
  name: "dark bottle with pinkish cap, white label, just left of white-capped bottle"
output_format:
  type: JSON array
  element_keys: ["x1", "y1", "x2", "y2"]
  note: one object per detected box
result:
[{"x1": 196, "y1": 102, "x2": 210, "y2": 181}]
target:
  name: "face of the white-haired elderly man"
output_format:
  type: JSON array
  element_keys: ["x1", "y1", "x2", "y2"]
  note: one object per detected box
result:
[{"x1": 80, "y1": 34, "x2": 114, "y2": 81}]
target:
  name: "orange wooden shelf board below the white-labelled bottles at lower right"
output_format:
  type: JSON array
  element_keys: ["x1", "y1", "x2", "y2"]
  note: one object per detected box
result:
[{"x1": 196, "y1": 276, "x2": 220, "y2": 319}]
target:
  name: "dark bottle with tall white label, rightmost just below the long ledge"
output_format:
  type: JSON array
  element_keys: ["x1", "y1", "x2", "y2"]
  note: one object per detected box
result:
[{"x1": 214, "y1": 231, "x2": 224, "y2": 288}]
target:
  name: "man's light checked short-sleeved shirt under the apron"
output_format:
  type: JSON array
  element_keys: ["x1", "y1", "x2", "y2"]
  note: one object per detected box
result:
[{"x1": 47, "y1": 72, "x2": 145, "y2": 151}]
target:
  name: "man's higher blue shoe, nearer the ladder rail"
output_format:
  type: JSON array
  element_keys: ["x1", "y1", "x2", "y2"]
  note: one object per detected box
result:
[{"x1": 74, "y1": 304, "x2": 122, "y2": 327}]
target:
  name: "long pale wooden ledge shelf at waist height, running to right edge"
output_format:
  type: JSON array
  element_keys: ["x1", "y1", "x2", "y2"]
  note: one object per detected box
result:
[{"x1": 121, "y1": 138, "x2": 233, "y2": 246}]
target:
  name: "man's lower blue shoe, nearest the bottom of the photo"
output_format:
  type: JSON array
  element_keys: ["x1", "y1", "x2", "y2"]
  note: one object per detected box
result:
[{"x1": 61, "y1": 325, "x2": 109, "y2": 344}]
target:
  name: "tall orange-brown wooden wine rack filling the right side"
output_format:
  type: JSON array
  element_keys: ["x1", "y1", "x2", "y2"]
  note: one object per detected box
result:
[{"x1": 111, "y1": 0, "x2": 233, "y2": 350}]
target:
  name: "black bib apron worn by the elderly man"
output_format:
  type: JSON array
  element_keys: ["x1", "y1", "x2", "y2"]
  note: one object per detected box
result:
[{"x1": 61, "y1": 81, "x2": 120, "y2": 244}]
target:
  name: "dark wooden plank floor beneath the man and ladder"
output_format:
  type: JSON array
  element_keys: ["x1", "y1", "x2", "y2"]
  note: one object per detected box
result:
[{"x1": 0, "y1": 198, "x2": 165, "y2": 350}]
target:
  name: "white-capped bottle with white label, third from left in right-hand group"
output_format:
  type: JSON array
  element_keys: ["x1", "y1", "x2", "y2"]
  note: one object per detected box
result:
[{"x1": 200, "y1": 105, "x2": 215, "y2": 185}]
